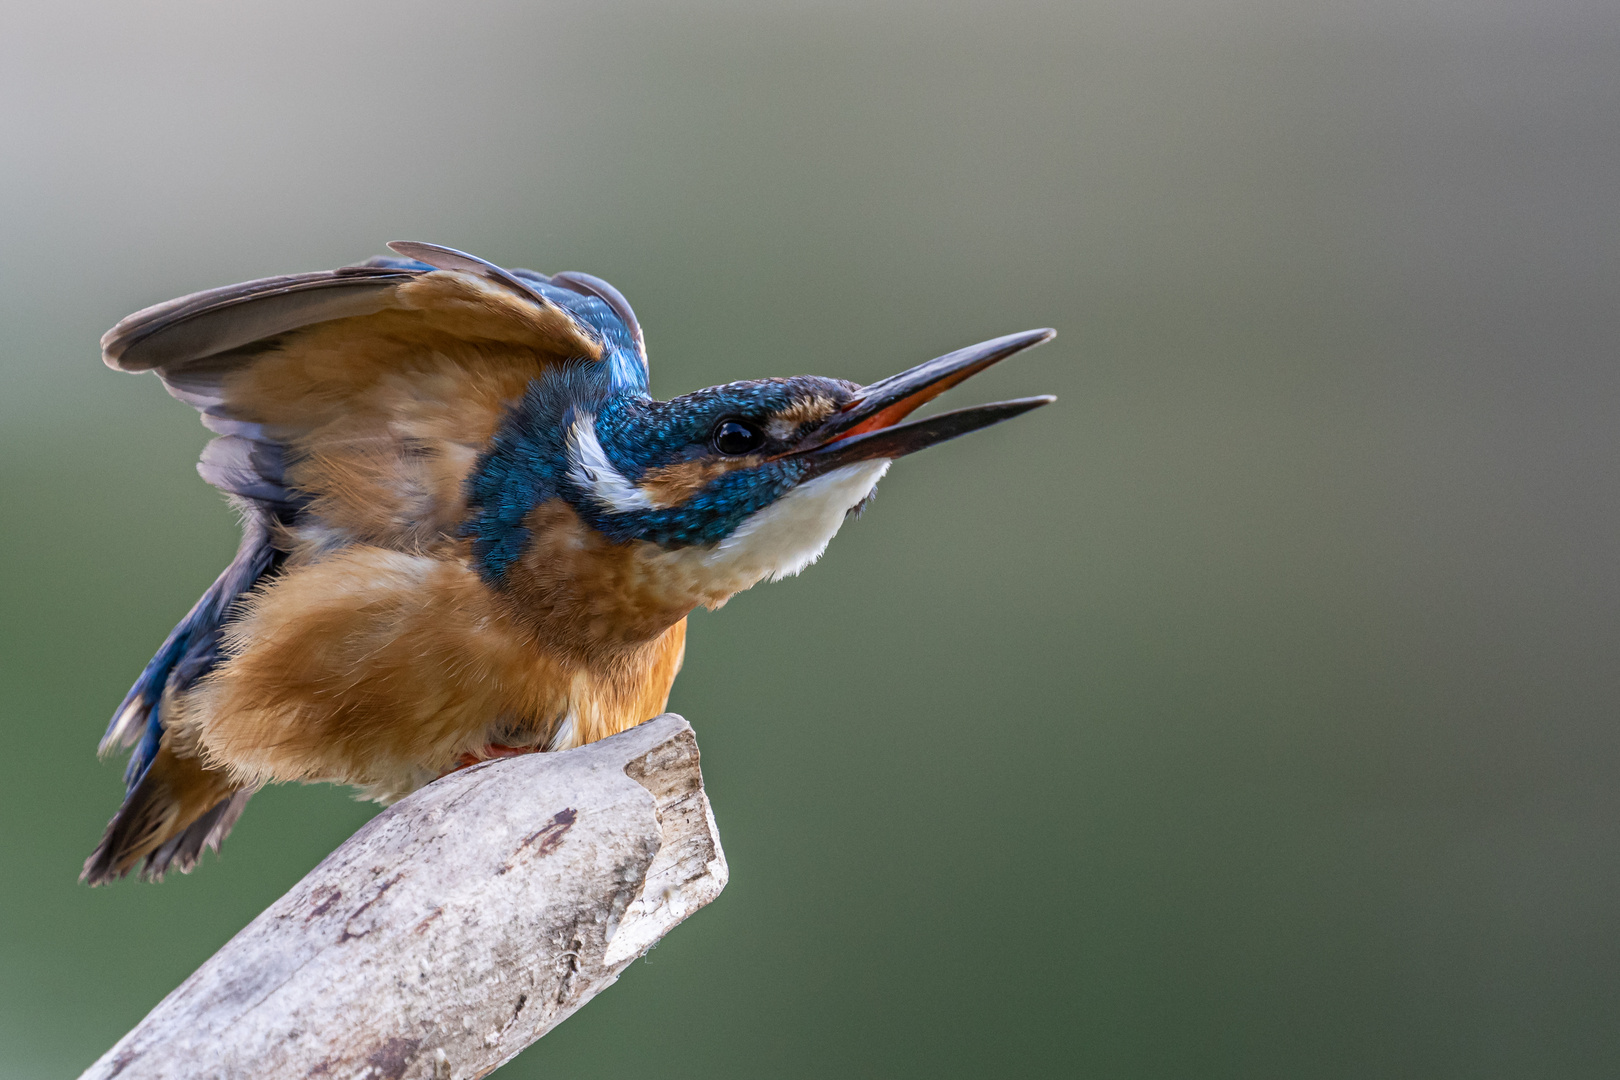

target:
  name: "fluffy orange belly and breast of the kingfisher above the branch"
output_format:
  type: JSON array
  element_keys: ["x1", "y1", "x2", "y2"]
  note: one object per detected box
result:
[{"x1": 175, "y1": 544, "x2": 685, "y2": 801}]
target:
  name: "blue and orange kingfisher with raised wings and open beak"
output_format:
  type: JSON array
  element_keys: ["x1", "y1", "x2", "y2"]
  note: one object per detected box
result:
[{"x1": 81, "y1": 243, "x2": 1053, "y2": 884}]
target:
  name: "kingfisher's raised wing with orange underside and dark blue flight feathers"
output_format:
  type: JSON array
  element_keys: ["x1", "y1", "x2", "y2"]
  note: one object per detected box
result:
[{"x1": 102, "y1": 243, "x2": 646, "y2": 767}]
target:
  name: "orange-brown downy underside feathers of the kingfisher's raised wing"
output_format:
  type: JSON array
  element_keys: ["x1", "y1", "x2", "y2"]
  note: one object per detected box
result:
[{"x1": 212, "y1": 270, "x2": 601, "y2": 559}]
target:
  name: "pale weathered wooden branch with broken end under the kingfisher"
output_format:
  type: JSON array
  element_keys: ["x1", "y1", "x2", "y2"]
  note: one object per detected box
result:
[{"x1": 84, "y1": 714, "x2": 727, "y2": 1080}]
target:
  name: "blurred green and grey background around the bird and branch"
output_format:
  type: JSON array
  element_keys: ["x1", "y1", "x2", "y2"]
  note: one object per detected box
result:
[{"x1": 0, "y1": 0, "x2": 1620, "y2": 1078}]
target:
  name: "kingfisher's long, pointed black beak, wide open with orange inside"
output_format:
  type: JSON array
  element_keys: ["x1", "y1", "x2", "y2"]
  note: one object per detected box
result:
[{"x1": 792, "y1": 330, "x2": 1056, "y2": 470}]
